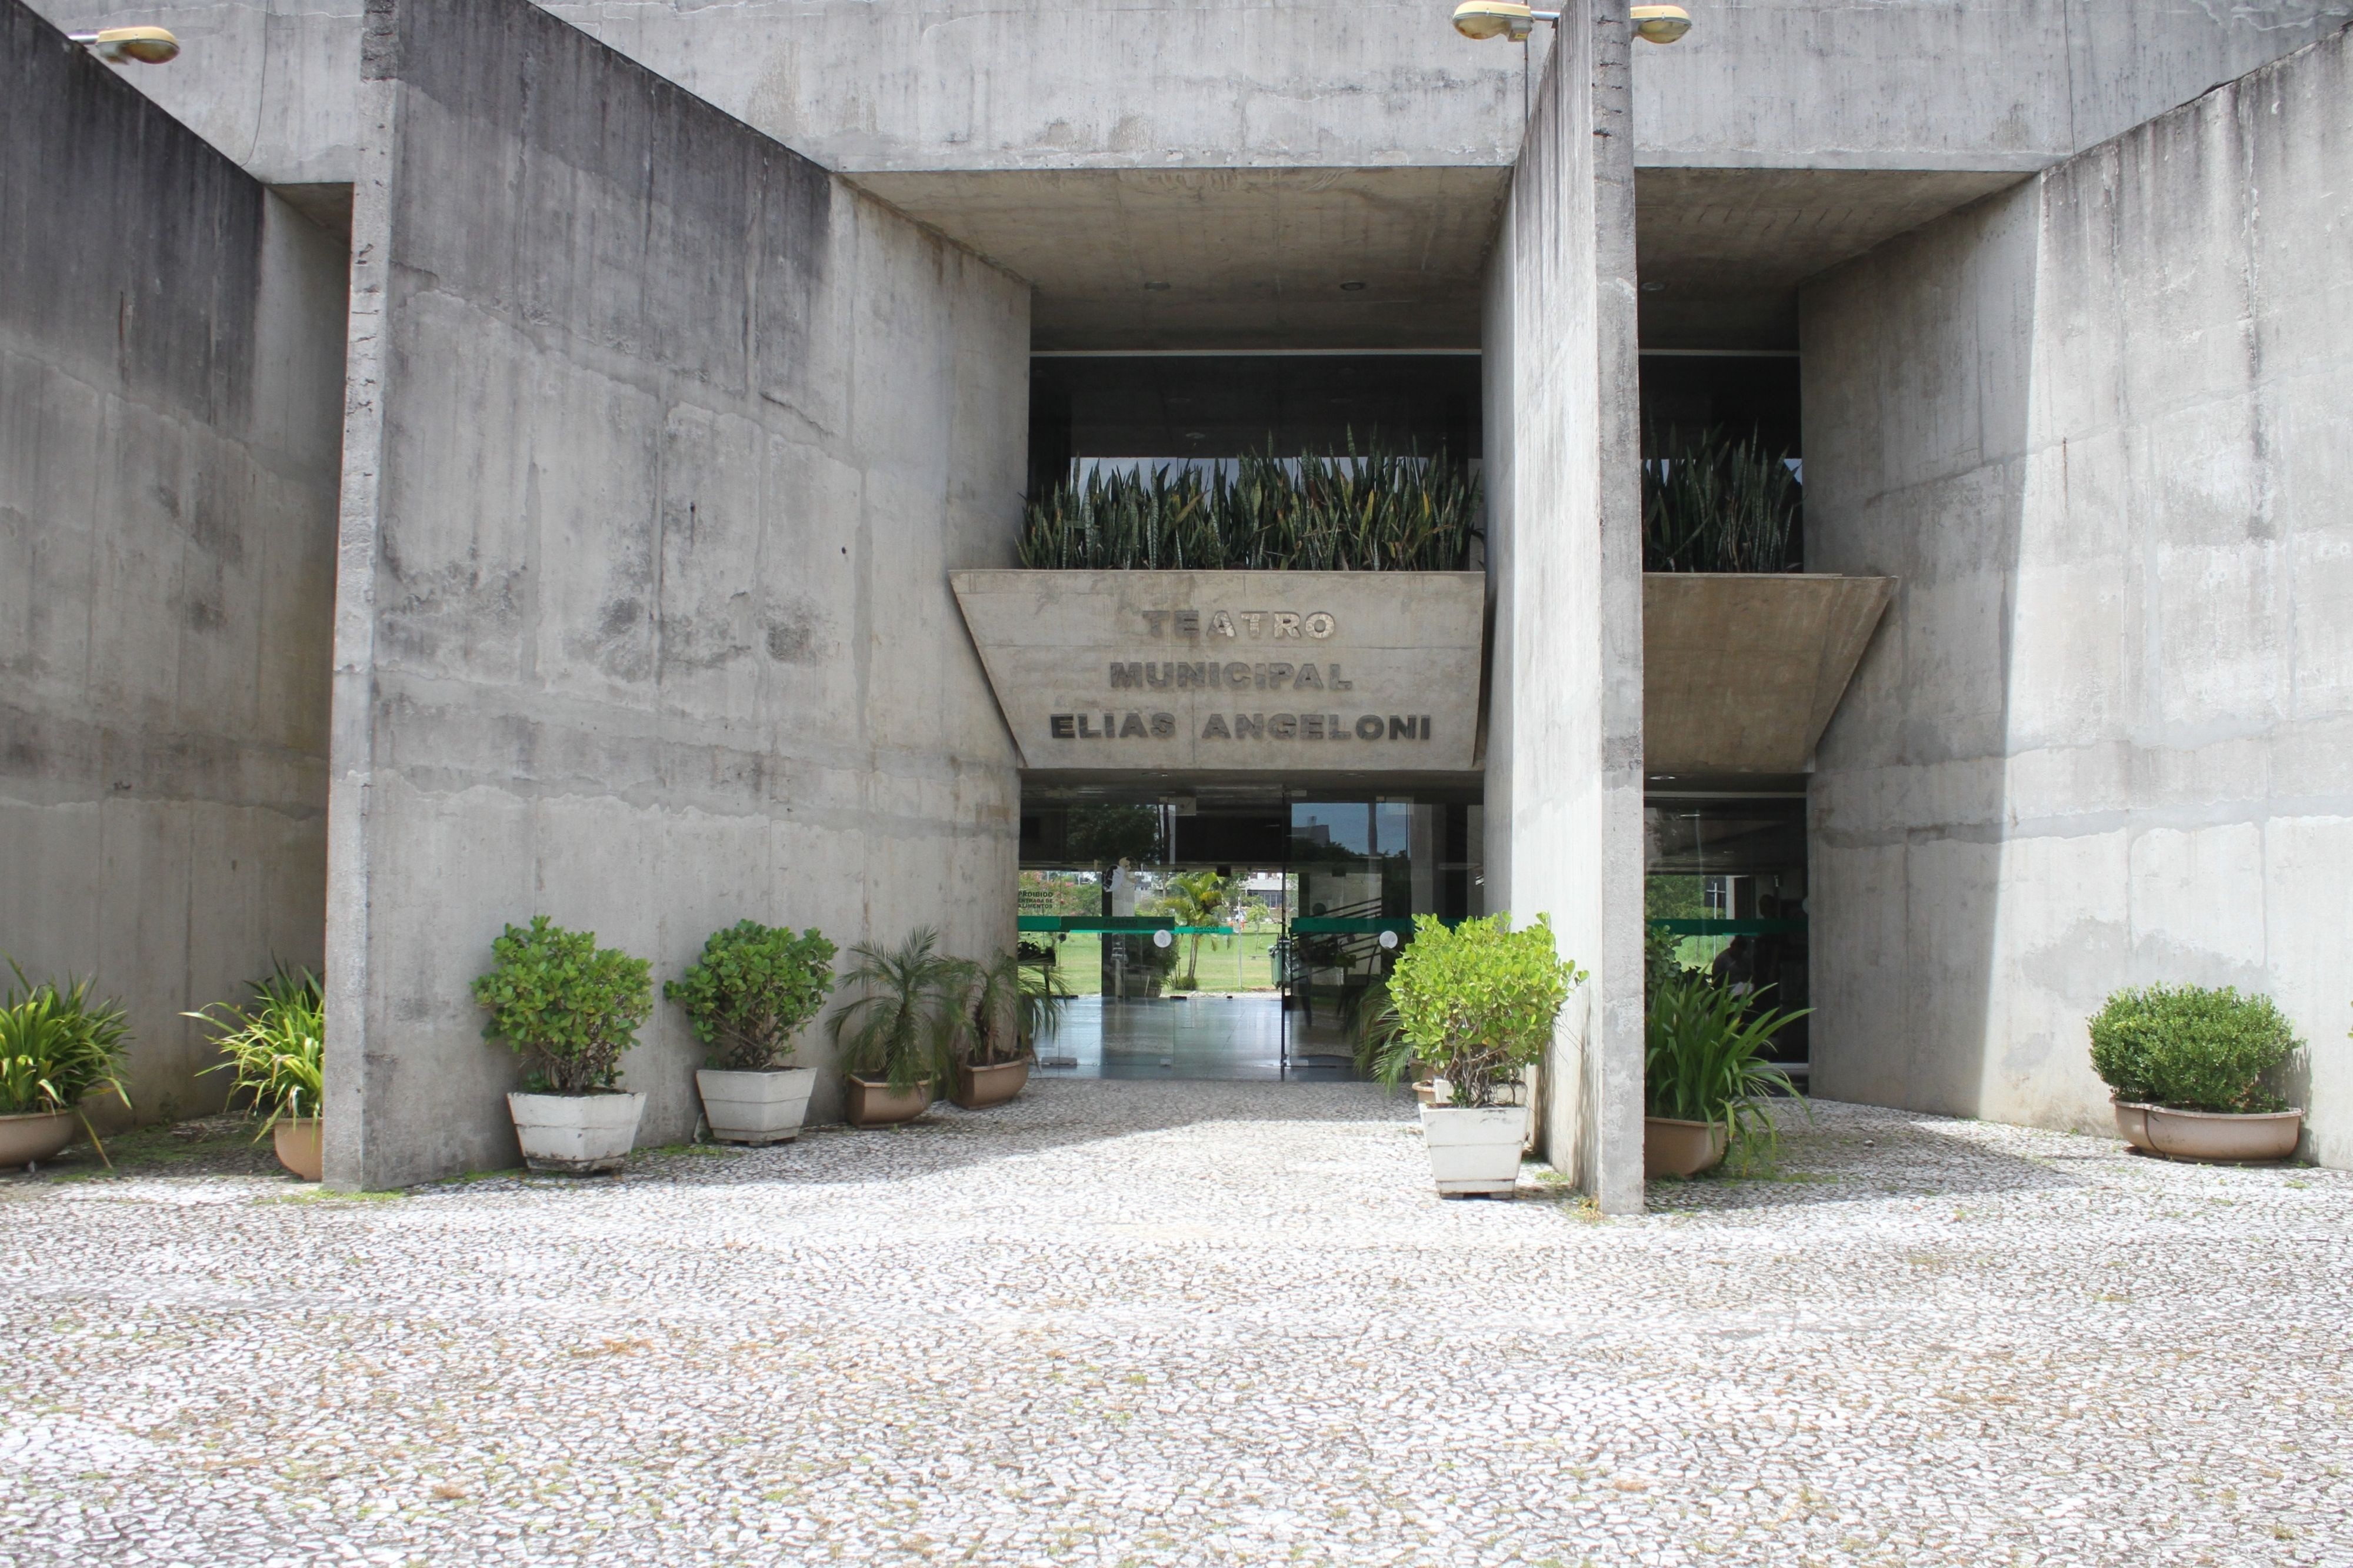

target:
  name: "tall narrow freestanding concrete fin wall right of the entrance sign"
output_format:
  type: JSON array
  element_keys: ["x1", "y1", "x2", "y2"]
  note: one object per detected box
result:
[{"x1": 1485, "y1": 0, "x2": 1642, "y2": 1213}]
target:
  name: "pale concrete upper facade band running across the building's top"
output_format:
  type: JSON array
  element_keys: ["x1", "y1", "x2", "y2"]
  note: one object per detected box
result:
[{"x1": 23, "y1": 0, "x2": 2353, "y2": 184}]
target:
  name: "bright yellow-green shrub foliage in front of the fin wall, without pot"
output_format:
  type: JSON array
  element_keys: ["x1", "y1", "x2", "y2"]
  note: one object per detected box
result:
[{"x1": 1388, "y1": 913, "x2": 1586, "y2": 1106}]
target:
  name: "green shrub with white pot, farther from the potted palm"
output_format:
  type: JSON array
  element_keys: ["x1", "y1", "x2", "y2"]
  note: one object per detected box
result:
[{"x1": 473, "y1": 916, "x2": 654, "y2": 1172}]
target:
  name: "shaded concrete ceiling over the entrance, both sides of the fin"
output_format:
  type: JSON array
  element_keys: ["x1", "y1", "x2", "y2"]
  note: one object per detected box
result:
[{"x1": 856, "y1": 165, "x2": 2026, "y2": 351}]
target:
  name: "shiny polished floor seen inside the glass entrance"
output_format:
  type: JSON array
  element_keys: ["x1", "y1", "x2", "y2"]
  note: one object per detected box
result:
[{"x1": 1038, "y1": 991, "x2": 1355, "y2": 1083}]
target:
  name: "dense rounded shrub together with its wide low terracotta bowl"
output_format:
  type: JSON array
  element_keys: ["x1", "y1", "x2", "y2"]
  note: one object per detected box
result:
[{"x1": 2089, "y1": 986, "x2": 2304, "y2": 1160}]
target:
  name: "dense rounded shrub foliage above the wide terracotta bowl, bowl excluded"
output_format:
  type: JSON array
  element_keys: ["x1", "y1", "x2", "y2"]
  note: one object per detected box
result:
[{"x1": 2092, "y1": 986, "x2": 2301, "y2": 1111}]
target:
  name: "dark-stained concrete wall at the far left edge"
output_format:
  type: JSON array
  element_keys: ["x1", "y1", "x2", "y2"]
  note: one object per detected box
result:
[{"x1": 0, "y1": 0, "x2": 344, "y2": 1116}]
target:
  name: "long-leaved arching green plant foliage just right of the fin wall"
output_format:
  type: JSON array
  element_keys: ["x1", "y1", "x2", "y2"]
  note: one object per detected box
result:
[{"x1": 1642, "y1": 970, "x2": 1812, "y2": 1144}]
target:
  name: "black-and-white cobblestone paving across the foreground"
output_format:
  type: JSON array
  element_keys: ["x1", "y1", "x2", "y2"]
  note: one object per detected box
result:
[{"x1": 0, "y1": 1083, "x2": 2353, "y2": 1566}]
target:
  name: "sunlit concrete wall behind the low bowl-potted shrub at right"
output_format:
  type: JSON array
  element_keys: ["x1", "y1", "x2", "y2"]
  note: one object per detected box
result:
[{"x1": 1805, "y1": 33, "x2": 2353, "y2": 1165}]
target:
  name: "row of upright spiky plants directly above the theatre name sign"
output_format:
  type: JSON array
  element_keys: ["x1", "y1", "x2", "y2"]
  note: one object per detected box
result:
[{"x1": 1019, "y1": 441, "x2": 1485, "y2": 572}]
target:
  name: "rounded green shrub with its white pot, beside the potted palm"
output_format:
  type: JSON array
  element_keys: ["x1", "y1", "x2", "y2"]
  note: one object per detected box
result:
[{"x1": 664, "y1": 920, "x2": 833, "y2": 1144}]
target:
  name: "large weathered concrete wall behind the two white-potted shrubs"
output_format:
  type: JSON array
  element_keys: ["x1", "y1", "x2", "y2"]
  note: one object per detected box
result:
[{"x1": 327, "y1": 0, "x2": 1028, "y2": 1187}]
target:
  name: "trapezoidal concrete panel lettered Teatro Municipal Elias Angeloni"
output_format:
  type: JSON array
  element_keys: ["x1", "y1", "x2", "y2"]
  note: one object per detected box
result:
[{"x1": 955, "y1": 572, "x2": 1487, "y2": 775}]
